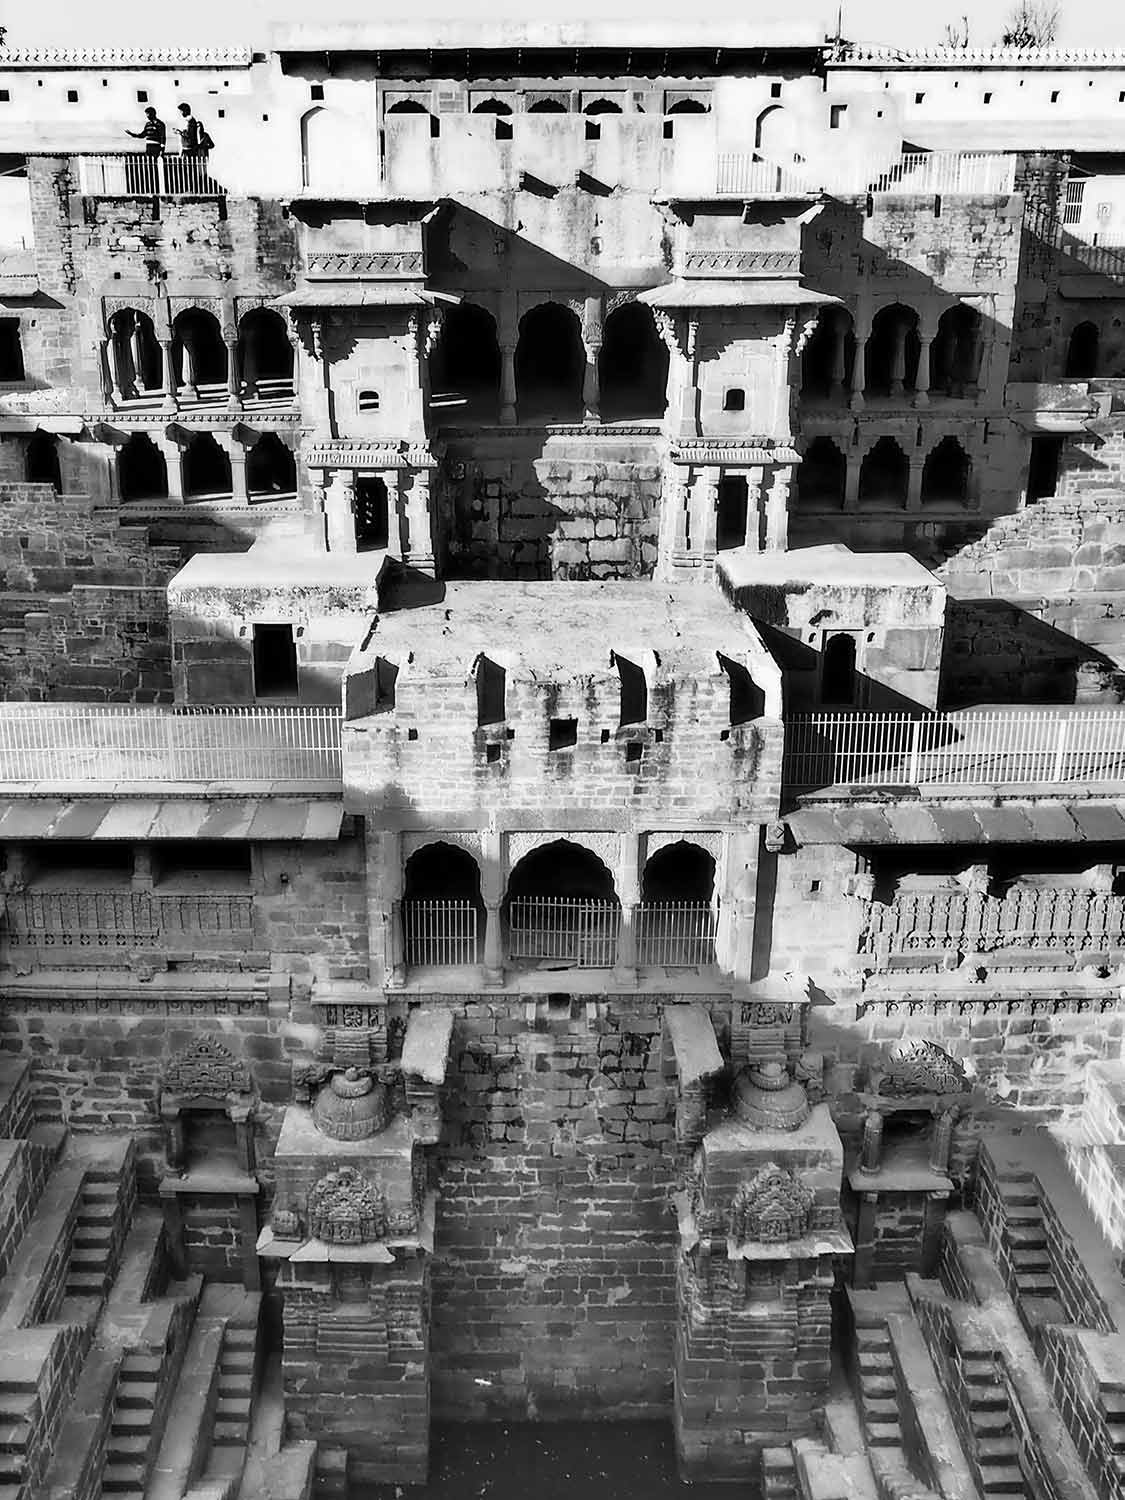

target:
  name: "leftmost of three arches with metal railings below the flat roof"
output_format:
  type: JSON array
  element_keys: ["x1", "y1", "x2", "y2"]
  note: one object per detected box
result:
[{"x1": 402, "y1": 843, "x2": 485, "y2": 968}]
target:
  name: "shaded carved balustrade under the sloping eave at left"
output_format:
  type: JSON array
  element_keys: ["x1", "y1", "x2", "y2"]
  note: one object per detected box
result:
[{"x1": 0, "y1": 891, "x2": 254, "y2": 953}]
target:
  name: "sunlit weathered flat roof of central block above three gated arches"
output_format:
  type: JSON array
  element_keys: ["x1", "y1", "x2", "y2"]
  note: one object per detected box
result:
[{"x1": 366, "y1": 581, "x2": 777, "y2": 686}]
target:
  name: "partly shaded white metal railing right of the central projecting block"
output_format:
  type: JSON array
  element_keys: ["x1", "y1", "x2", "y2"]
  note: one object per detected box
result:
[{"x1": 782, "y1": 708, "x2": 1125, "y2": 791}]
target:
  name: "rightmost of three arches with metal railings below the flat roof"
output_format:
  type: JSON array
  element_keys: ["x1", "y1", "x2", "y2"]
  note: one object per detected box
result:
[{"x1": 636, "y1": 840, "x2": 716, "y2": 969}]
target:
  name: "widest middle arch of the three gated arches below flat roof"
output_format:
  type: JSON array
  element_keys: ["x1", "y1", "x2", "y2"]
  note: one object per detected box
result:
[{"x1": 504, "y1": 839, "x2": 621, "y2": 969}]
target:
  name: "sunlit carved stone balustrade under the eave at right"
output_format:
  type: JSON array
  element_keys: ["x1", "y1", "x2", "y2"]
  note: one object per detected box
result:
[{"x1": 860, "y1": 885, "x2": 1125, "y2": 971}]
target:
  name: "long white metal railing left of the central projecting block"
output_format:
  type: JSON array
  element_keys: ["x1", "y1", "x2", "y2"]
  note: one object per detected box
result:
[{"x1": 0, "y1": 704, "x2": 341, "y2": 786}]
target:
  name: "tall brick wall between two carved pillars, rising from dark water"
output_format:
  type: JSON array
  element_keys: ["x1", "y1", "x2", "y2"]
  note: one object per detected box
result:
[{"x1": 432, "y1": 999, "x2": 677, "y2": 1421}]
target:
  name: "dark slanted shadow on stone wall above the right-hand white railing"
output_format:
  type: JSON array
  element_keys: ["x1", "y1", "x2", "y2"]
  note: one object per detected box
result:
[{"x1": 941, "y1": 599, "x2": 1125, "y2": 708}]
